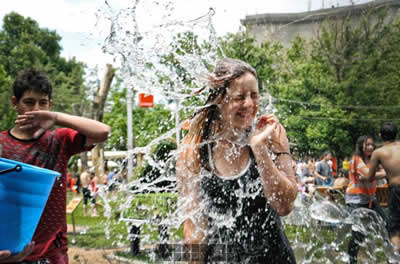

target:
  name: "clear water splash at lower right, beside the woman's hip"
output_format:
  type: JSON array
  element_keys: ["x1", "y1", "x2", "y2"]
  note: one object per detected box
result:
[{"x1": 284, "y1": 190, "x2": 400, "y2": 263}]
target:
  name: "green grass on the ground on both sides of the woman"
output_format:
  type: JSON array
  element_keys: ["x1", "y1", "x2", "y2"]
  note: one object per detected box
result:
[{"x1": 67, "y1": 193, "x2": 385, "y2": 263}]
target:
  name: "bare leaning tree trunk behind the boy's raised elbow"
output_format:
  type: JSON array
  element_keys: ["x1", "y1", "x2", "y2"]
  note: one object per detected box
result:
[{"x1": 91, "y1": 64, "x2": 115, "y2": 184}]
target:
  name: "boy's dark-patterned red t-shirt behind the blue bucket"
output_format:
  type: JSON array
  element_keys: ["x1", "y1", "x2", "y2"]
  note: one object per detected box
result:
[{"x1": 0, "y1": 128, "x2": 90, "y2": 261}]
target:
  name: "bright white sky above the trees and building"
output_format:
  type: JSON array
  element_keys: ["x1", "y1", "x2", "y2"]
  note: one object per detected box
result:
[{"x1": 0, "y1": 0, "x2": 372, "y2": 70}]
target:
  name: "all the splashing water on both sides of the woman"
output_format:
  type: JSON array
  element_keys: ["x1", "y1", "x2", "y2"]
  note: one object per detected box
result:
[{"x1": 79, "y1": 0, "x2": 399, "y2": 263}]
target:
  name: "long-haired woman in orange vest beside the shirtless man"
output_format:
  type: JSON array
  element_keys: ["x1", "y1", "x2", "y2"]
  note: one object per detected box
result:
[{"x1": 345, "y1": 135, "x2": 387, "y2": 264}]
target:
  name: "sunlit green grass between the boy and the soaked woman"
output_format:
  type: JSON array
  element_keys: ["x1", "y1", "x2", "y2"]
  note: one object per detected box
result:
[{"x1": 67, "y1": 193, "x2": 183, "y2": 248}]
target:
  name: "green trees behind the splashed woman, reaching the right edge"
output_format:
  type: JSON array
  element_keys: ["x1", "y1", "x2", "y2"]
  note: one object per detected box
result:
[{"x1": 102, "y1": 9, "x2": 400, "y2": 160}]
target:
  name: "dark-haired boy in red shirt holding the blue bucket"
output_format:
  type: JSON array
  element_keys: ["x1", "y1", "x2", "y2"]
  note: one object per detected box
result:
[{"x1": 0, "y1": 68, "x2": 110, "y2": 264}]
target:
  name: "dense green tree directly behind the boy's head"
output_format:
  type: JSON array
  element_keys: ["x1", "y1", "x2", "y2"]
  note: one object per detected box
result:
[{"x1": 0, "y1": 12, "x2": 86, "y2": 129}]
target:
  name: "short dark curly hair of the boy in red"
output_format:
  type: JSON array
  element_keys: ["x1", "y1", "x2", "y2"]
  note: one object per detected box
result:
[{"x1": 13, "y1": 68, "x2": 53, "y2": 101}]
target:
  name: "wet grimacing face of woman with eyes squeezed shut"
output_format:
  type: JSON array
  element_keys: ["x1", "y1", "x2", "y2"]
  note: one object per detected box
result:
[{"x1": 220, "y1": 72, "x2": 259, "y2": 130}]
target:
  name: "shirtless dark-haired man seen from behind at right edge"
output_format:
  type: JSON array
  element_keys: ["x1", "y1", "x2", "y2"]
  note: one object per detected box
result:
[{"x1": 361, "y1": 122, "x2": 400, "y2": 249}]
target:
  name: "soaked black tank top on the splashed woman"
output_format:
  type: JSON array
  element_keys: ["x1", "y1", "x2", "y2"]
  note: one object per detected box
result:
[{"x1": 201, "y1": 147, "x2": 296, "y2": 263}]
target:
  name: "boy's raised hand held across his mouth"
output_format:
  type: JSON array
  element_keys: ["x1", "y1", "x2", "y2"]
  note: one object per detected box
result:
[{"x1": 15, "y1": 111, "x2": 57, "y2": 138}]
